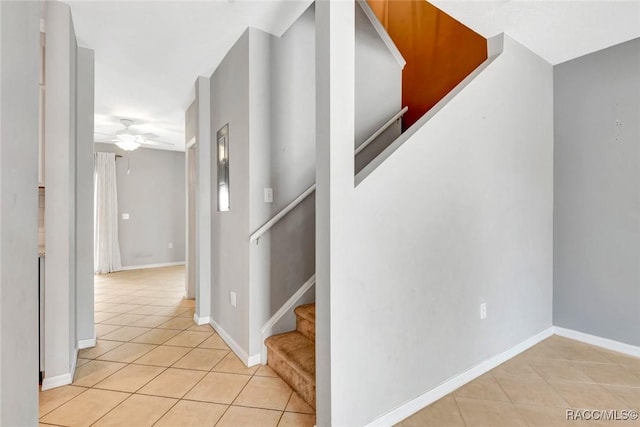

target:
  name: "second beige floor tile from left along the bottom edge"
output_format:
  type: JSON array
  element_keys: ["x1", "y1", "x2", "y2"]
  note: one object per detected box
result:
[{"x1": 93, "y1": 394, "x2": 177, "y2": 427}]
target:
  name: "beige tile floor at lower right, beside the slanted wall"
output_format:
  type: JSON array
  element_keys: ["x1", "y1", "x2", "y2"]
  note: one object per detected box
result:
[{"x1": 397, "y1": 336, "x2": 640, "y2": 427}]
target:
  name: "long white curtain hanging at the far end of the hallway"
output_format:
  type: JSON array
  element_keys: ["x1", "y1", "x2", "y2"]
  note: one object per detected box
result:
[{"x1": 93, "y1": 153, "x2": 122, "y2": 273}]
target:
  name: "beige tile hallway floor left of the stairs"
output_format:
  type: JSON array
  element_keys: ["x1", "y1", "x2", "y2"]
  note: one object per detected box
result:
[{"x1": 40, "y1": 267, "x2": 315, "y2": 427}]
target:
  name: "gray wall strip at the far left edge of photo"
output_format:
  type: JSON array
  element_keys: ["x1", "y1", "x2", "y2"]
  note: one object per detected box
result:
[{"x1": 0, "y1": 2, "x2": 39, "y2": 426}]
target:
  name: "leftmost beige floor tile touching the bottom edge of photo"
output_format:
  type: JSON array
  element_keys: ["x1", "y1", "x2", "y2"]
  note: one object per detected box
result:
[{"x1": 40, "y1": 389, "x2": 129, "y2": 427}]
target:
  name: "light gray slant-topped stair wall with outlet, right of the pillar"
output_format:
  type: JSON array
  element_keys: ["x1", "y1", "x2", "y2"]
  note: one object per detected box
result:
[{"x1": 318, "y1": 37, "x2": 553, "y2": 426}]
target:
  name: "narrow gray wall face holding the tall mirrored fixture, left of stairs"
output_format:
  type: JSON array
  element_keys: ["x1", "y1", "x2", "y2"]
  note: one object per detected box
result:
[{"x1": 211, "y1": 30, "x2": 250, "y2": 357}]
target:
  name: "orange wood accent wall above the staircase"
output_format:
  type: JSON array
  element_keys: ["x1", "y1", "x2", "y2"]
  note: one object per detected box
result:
[{"x1": 367, "y1": 0, "x2": 487, "y2": 130}]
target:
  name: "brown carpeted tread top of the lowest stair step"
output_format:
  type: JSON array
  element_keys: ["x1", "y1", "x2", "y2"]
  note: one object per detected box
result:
[{"x1": 265, "y1": 331, "x2": 316, "y2": 383}]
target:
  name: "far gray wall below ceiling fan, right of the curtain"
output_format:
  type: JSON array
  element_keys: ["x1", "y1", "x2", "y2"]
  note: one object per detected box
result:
[{"x1": 94, "y1": 143, "x2": 186, "y2": 267}]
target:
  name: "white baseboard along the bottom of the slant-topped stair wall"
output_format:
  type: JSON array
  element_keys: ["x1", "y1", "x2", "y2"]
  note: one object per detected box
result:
[{"x1": 367, "y1": 326, "x2": 554, "y2": 427}]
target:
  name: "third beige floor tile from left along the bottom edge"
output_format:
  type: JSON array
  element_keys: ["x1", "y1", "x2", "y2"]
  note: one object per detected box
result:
[{"x1": 154, "y1": 400, "x2": 227, "y2": 427}]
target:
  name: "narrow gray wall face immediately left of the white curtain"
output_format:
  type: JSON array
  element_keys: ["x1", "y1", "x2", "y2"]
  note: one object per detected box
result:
[{"x1": 76, "y1": 48, "x2": 95, "y2": 346}]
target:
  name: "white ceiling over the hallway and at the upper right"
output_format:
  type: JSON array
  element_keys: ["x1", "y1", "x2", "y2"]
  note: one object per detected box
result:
[{"x1": 67, "y1": 0, "x2": 640, "y2": 151}]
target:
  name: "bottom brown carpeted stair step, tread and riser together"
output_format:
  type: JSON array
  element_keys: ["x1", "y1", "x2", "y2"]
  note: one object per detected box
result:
[{"x1": 265, "y1": 331, "x2": 316, "y2": 408}]
